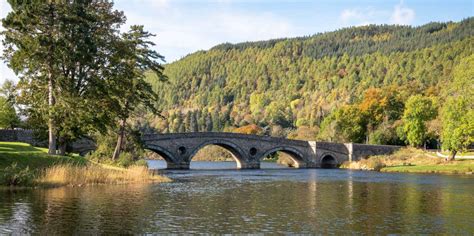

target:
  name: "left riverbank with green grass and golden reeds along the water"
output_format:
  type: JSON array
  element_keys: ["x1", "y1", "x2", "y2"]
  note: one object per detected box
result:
[{"x1": 0, "y1": 142, "x2": 170, "y2": 187}]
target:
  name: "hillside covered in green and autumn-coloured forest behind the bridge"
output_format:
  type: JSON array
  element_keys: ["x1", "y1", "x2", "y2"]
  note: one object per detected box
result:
[{"x1": 148, "y1": 17, "x2": 474, "y2": 143}]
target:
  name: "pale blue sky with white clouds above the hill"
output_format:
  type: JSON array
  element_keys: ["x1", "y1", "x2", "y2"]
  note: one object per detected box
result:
[{"x1": 0, "y1": 0, "x2": 474, "y2": 84}]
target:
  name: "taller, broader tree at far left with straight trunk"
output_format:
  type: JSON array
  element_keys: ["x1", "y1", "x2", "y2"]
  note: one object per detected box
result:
[{"x1": 2, "y1": 1, "x2": 125, "y2": 154}]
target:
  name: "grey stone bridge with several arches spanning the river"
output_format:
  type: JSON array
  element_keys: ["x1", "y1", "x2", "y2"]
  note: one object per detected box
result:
[{"x1": 142, "y1": 132, "x2": 400, "y2": 169}]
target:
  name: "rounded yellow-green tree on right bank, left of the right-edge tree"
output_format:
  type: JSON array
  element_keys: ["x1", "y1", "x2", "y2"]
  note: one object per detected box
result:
[{"x1": 402, "y1": 95, "x2": 436, "y2": 147}]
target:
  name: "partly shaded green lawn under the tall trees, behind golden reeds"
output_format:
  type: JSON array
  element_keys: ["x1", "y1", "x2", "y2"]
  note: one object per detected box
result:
[{"x1": 0, "y1": 142, "x2": 87, "y2": 171}]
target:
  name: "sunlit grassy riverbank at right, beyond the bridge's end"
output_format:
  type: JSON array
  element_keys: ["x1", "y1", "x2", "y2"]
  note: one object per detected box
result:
[{"x1": 341, "y1": 148, "x2": 474, "y2": 174}]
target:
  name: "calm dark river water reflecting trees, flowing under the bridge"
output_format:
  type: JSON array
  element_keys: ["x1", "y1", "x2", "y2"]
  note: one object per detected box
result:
[{"x1": 0, "y1": 161, "x2": 474, "y2": 235}]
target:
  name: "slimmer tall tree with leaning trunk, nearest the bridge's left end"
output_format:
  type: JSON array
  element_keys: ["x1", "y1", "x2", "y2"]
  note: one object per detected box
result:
[{"x1": 107, "y1": 25, "x2": 165, "y2": 160}]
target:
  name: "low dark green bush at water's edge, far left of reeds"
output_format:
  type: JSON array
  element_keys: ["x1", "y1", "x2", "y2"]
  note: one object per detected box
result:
[{"x1": 0, "y1": 163, "x2": 35, "y2": 186}]
